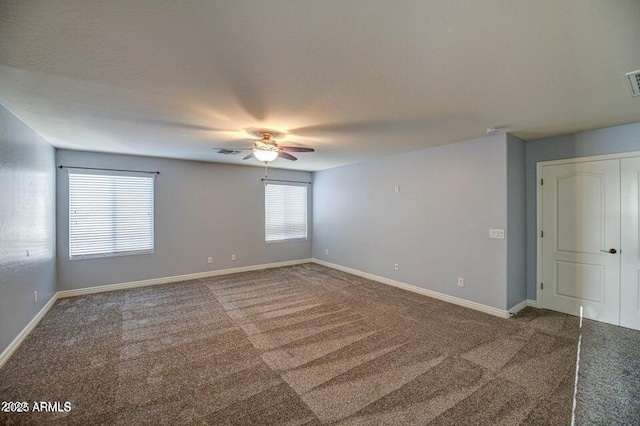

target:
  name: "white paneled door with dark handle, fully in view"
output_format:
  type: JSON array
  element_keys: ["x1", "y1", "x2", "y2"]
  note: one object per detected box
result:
[{"x1": 541, "y1": 160, "x2": 620, "y2": 324}]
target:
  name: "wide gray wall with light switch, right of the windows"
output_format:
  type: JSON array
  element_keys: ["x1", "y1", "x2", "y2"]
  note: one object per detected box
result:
[{"x1": 313, "y1": 134, "x2": 507, "y2": 309}]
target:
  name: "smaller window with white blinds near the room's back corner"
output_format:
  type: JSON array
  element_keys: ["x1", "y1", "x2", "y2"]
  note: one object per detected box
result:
[{"x1": 264, "y1": 183, "x2": 307, "y2": 242}]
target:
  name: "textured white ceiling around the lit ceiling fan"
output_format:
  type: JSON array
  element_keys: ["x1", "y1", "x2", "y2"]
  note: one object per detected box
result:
[{"x1": 0, "y1": 0, "x2": 640, "y2": 170}]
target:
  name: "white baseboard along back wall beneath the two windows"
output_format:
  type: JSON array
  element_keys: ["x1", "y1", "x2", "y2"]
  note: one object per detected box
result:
[{"x1": 58, "y1": 259, "x2": 312, "y2": 299}]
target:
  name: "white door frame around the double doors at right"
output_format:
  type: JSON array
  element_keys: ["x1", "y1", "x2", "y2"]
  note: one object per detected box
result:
[{"x1": 536, "y1": 151, "x2": 640, "y2": 308}]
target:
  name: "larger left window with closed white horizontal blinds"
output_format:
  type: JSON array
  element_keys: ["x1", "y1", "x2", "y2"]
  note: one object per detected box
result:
[{"x1": 69, "y1": 169, "x2": 155, "y2": 259}]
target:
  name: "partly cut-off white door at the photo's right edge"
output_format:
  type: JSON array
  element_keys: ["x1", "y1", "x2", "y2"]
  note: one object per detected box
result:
[{"x1": 620, "y1": 157, "x2": 640, "y2": 330}]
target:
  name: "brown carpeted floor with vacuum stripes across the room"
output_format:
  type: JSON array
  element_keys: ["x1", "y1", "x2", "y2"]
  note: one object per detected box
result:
[{"x1": 0, "y1": 264, "x2": 640, "y2": 425}]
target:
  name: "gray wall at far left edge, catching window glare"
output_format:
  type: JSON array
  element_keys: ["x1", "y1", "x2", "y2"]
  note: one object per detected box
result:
[{"x1": 0, "y1": 106, "x2": 56, "y2": 352}]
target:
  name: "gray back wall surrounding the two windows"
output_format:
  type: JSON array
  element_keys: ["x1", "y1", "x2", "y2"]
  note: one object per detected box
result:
[{"x1": 56, "y1": 150, "x2": 312, "y2": 290}]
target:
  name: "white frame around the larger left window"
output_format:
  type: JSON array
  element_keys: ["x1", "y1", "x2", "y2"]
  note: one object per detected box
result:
[{"x1": 67, "y1": 168, "x2": 156, "y2": 260}]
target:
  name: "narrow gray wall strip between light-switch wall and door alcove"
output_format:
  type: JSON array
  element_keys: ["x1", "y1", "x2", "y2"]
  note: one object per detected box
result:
[{"x1": 506, "y1": 134, "x2": 527, "y2": 308}]
